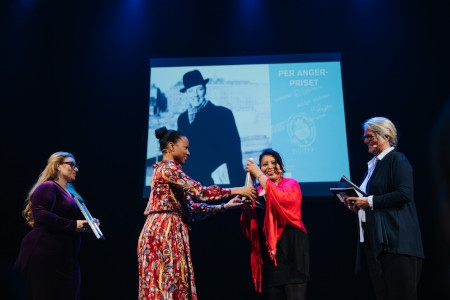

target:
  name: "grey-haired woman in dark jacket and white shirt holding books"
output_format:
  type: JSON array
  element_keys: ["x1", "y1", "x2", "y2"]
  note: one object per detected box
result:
[{"x1": 345, "y1": 117, "x2": 424, "y2": 300}]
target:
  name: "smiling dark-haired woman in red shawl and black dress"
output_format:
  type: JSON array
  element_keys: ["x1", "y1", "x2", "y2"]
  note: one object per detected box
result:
[{"x1": 241, "y1": 149, "x2": 309, "y2": 300}]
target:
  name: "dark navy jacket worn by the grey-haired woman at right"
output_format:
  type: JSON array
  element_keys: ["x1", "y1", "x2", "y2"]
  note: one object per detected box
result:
[{"x1": 366, "y1": 150, "x2": 424, "y2": 258}]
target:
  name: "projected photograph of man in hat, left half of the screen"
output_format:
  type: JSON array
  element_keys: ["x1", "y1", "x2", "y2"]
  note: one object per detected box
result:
[{"x1": 146, "y1": 65, "x2": 271, "y2": 193}]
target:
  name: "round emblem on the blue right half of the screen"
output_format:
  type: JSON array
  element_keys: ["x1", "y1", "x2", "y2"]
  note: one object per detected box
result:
[{"x1": 288, "y1": 114, "x2": 316, "y2": 147}]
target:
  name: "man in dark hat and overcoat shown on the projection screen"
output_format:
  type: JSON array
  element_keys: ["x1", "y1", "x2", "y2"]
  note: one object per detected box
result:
[{"x1": 178, "y1": 70, "x2": 245, "y2": 186}]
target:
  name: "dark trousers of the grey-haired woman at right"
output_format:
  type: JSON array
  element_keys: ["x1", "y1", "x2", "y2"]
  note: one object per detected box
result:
[{"x1": 361, "y1": 242, "x2": 422, "y2": 300}]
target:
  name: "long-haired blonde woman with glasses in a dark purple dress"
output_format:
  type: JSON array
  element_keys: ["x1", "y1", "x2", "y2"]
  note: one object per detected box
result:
[{"x1": 14, "y1": 152, "x2": 98, "y2": 300}]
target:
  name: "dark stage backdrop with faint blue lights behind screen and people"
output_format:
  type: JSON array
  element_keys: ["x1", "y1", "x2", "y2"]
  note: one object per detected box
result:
[{"x1": 0, "y1": 0, "x2": 450, "y2": 299}]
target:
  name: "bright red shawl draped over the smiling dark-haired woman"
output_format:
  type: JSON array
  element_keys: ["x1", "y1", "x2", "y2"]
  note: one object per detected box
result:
[{"x1": 240, "y1": 177, "x2": 306, "y2": 293}]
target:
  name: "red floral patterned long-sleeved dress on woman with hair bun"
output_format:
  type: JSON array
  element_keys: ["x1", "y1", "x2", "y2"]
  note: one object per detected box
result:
[{"x1": 137, "y1": 160, "x2": 231, "y2": 300}]
